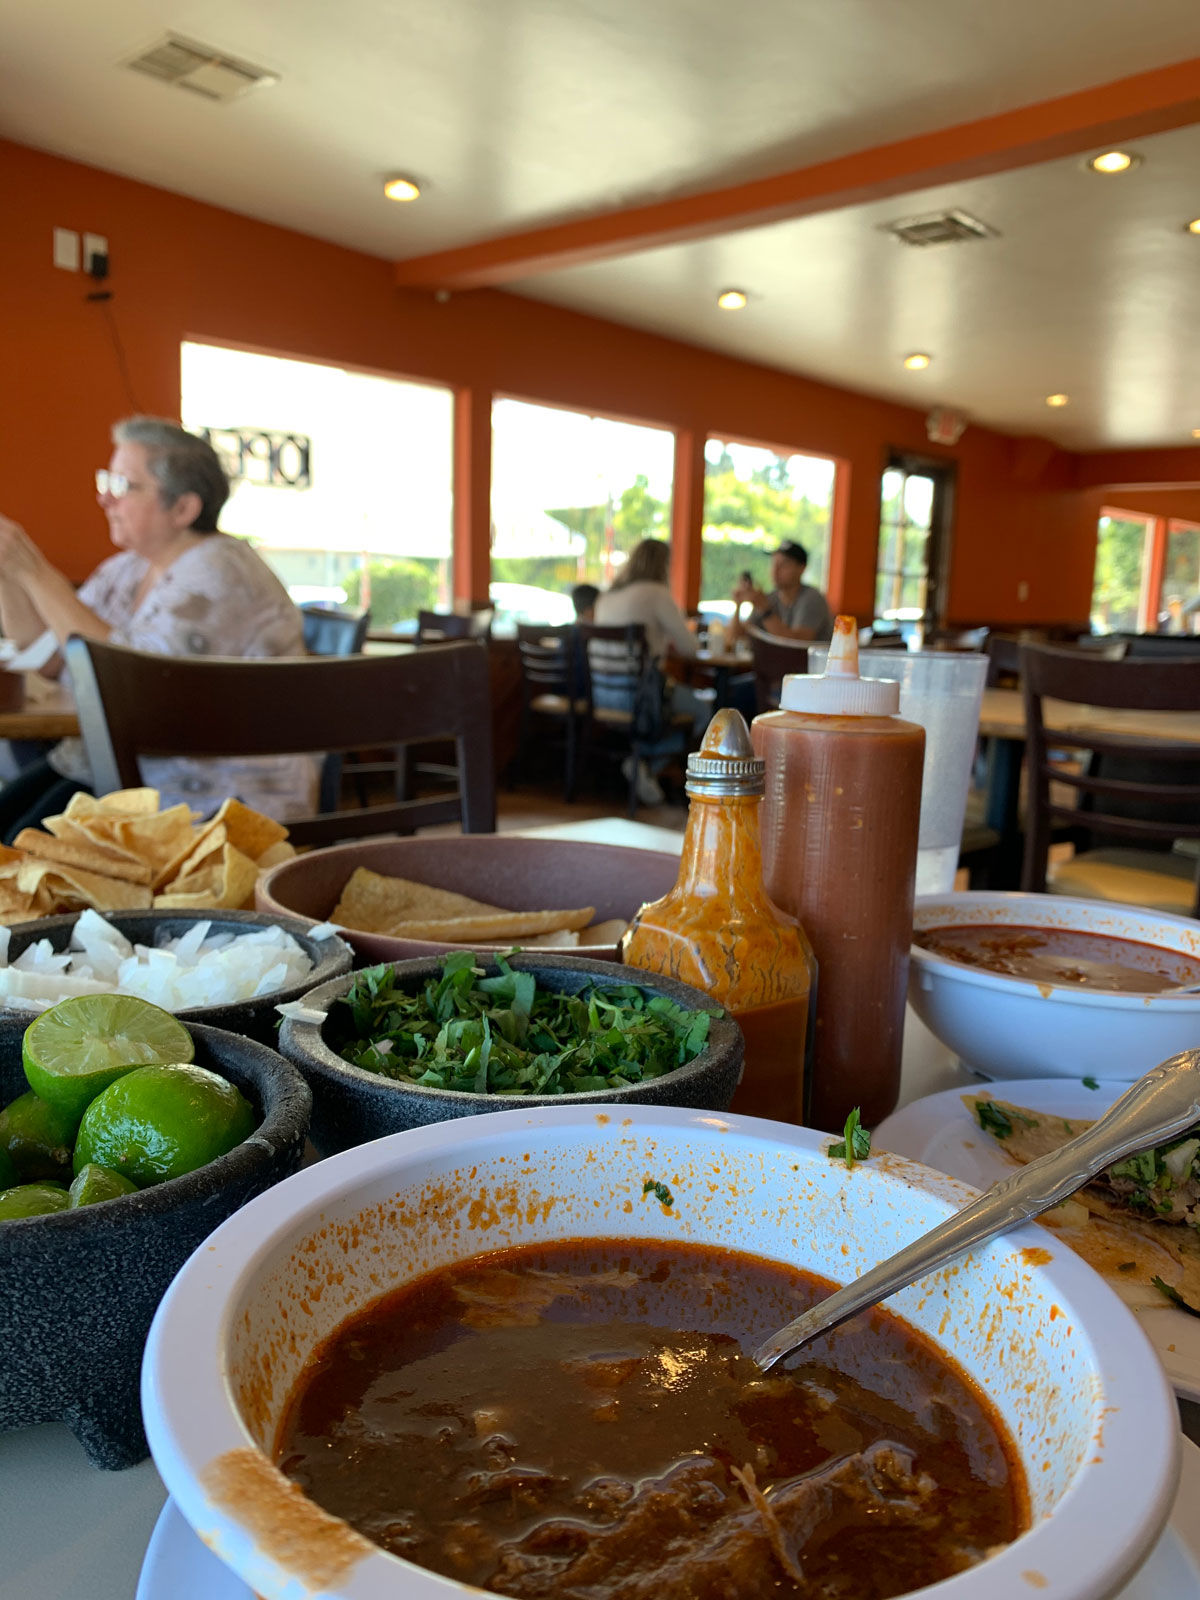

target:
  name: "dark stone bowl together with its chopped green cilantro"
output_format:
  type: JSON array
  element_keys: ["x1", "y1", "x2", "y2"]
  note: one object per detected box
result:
[{"x1": 280, "y1": 950, "x2": 742, "y2": 1155}]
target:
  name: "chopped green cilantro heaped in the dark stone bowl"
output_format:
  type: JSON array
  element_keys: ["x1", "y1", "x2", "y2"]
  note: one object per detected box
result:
[{"x1": 331, "y1": 950, "x2": 722, "y2": 1094}]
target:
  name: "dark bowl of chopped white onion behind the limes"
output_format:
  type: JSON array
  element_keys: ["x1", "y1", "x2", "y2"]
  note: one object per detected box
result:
[{"x1": 0, "y1": 910, "x2": 354, "y2": 1046}]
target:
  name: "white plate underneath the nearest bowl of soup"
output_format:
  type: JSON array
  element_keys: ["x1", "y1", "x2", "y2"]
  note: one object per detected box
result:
[{"x1": 138, "y1": 1438, "x2": 1200, "y2": 1600}]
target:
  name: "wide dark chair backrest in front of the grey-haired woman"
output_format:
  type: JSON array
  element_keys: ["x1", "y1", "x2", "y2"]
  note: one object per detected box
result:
[{"x1": 66, "y1": 638, "x2": 496, "y2": 845}]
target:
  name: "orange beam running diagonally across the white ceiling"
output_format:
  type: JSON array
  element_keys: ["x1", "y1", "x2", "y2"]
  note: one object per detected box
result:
[{"x1": 395, "y1": 58, "x2": 1200, "y2": 290}]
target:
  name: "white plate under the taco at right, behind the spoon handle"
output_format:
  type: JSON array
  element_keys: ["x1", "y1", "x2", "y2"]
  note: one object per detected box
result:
[{"x1": 874, "y1": 1078, "x2": 1200, "y2": 1400}]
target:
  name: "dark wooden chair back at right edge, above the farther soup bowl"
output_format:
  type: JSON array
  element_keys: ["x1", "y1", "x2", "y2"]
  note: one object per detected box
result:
[{"x1": 1021, "y1": 645, "x2": 1200, "y2": 915}]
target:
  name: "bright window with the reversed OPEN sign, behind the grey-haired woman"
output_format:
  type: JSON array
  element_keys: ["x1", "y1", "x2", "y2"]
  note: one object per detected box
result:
[{"x1": 181, "y1": 342, "x2": 454, "y2": 627}]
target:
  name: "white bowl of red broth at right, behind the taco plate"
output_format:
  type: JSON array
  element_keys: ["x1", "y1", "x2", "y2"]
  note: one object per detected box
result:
[{"x1": 909, "y1": 891, "x2": 1200, "y2": 1080}]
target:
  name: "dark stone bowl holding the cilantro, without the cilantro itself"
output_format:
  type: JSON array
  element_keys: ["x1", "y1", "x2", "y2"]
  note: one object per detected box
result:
[{"x1": 280, "y1": 952, "x2": 742, "y2": 1155}]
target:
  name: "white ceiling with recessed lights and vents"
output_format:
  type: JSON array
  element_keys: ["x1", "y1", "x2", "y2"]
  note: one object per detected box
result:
[{"x1": 0, "y1": 0, "x2": 1200, "y2": 448}]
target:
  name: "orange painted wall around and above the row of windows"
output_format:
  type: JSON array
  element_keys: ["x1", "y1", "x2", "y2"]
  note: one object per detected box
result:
[{"x1": 0, "y1": 142, "x2": 1094, "y2": 622}]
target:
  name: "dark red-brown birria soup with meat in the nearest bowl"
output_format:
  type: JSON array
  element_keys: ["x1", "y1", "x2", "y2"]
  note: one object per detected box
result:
[{"x1": 277, "y1": 1240, "x2": 1029, "y2": 1600}]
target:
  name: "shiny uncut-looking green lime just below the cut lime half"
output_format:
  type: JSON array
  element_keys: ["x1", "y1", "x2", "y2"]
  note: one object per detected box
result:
[{"x1": 75, "y1": 1062, "x2": 254, "y2": 1189}]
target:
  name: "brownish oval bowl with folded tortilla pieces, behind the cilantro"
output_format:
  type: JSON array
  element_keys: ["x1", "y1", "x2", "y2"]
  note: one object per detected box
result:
[{"x1": 256, "y1": 834, "x2": 678, "y2": 962}]
